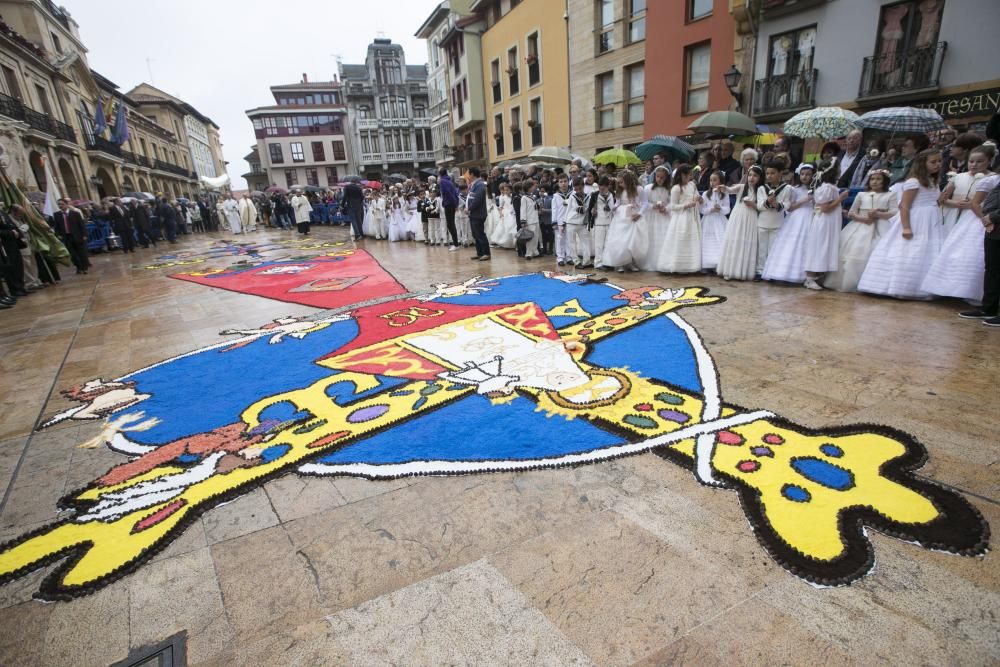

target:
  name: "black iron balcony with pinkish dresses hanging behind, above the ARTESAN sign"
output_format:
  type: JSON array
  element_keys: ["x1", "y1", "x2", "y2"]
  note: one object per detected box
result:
[{"x1": 858, "y1": 42, "x2": 948, "y2": 100}]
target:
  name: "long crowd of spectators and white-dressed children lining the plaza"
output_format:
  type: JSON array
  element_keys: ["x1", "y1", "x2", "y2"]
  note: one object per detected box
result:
[{"x1": 0, "y1": 122, "x2": 1000, "y2": 326}]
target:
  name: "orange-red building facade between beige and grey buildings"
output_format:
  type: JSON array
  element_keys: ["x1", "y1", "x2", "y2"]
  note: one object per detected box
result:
[{"x1": 645, "y1": 0, "x2": 736, "y2": 138}]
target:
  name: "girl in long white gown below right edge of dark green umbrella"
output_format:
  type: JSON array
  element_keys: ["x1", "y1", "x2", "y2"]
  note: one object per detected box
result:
[{"x1": 656, "y1": 164, "x2": 701, "y2": 273}]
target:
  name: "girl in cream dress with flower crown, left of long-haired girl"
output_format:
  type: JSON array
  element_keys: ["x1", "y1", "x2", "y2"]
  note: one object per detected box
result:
[{"x1": 823, "y1": 169, "x2": 899, "y2": 292}]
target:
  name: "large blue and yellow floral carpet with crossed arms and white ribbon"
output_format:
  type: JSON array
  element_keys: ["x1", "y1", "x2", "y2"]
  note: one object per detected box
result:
[{"x1": 0, "y1": 272, "x2": 989, "y2": 599}]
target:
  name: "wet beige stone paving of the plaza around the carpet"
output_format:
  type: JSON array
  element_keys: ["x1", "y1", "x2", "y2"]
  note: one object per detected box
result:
[{"x1": 0, "y1": 228, "x2": 1000, "y2": 667}]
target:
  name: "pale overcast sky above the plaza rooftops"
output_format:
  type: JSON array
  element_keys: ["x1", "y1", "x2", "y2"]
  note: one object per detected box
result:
[{"x1": 57, "y1": 0, "x2": 439, "y2": 190}]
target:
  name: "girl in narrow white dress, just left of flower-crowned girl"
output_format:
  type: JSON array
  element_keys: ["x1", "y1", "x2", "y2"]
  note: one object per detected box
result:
[{"x1": 802, "y1": 162, "x2": 848, "y2": 290}]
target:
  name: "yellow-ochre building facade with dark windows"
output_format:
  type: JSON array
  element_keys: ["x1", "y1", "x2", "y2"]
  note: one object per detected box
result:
[{"x1": 472, "y1": 0, "x2": 570, "y2": 163}]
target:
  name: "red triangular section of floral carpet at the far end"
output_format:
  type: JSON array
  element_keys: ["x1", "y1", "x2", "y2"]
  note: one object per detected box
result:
[{"x1": 170, "y1": 249, "x2": 406, "y2": 308}]
